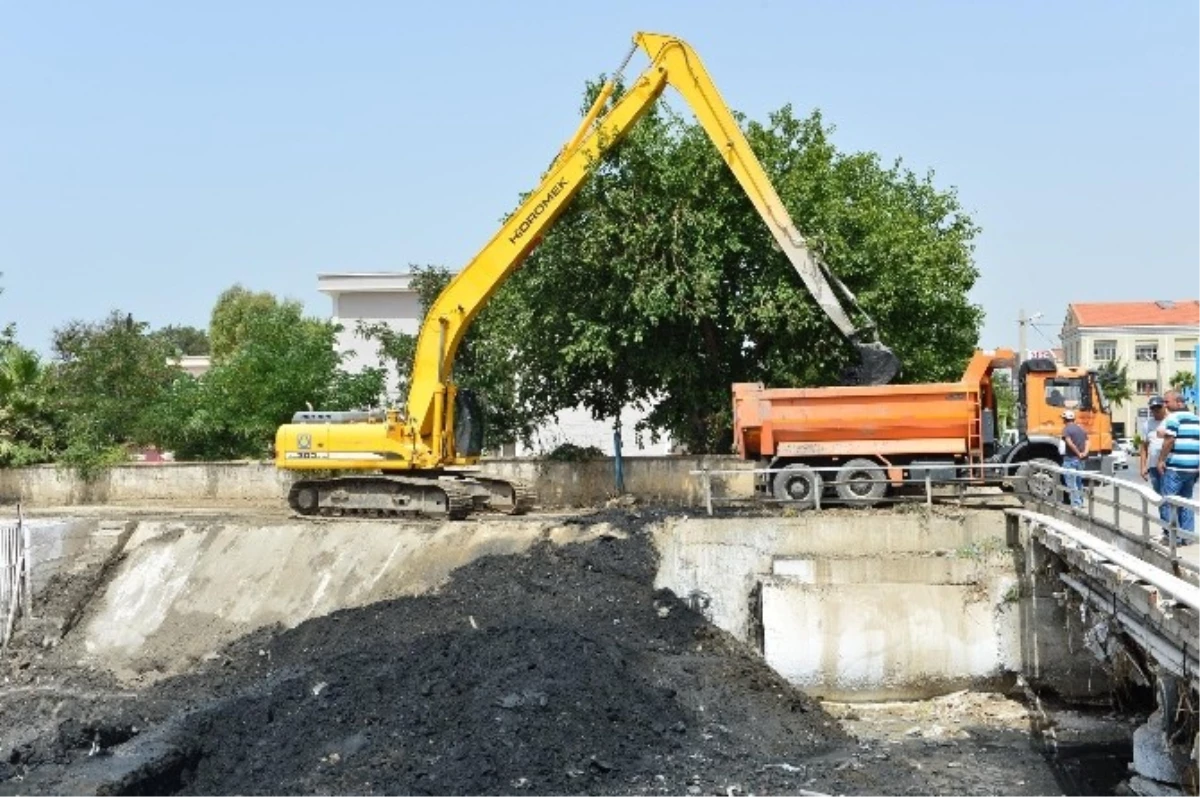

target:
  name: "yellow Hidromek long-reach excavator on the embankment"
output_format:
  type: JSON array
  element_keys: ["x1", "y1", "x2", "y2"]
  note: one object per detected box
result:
[{"x1": 275, "y1": 32, "x2": 899, "y2": 520}]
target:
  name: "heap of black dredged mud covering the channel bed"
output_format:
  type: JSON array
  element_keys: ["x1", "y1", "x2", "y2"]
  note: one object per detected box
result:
[{"x1": 0, "y1": 509, "x2": 1132, "y2": 797}]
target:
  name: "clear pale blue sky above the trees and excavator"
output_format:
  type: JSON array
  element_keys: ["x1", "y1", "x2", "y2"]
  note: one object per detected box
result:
[{"x1": 0, "y1": 0, "x2": 1200, "y2": 350}]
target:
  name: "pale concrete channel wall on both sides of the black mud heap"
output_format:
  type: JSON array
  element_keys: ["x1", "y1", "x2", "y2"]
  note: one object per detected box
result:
[{"x1": 18, "y1": 508, "x2": 1104, "y2": 700}]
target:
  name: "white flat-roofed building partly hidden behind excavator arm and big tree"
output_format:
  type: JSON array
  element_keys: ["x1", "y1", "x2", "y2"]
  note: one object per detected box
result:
[{"x1": 317, "y1": 272, "x2": 672, "y2": 456}]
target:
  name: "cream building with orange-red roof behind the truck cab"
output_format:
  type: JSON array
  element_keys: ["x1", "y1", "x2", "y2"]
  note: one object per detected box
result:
[{"x1": 1062, "y1": 299, "x2": 1200, "y2": 437}]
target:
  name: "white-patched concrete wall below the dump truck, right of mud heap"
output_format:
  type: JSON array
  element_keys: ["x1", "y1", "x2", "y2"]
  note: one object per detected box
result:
[{"x1": 658, "y1": 510, "x2": 1022, "y2": 700}]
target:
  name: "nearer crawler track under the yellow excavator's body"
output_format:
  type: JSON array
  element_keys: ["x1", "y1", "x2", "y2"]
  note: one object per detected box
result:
[{"x1": 288, "y1": 475, "x2": 475, "y2": 520}]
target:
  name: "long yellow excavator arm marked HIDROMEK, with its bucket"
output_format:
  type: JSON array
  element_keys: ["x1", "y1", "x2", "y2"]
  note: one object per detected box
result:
[{"x1": 408, "y1": 32, "x2": 899, "y2": 439}]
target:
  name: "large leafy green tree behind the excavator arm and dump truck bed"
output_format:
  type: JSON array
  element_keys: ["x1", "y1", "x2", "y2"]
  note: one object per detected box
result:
[{"x1": 480, "y1": 86, "x2": 983, "y2": 451}]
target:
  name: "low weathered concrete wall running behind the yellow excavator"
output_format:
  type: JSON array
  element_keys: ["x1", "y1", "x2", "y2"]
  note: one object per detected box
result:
[{"x1": 0, "y1": 456, "x2": 754, "y2": 507}]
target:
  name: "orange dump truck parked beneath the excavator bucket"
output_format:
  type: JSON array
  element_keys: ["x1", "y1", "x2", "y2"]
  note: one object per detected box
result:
[{"x1": 733, "y1": 349, "x2": 1112, "y2": 505}]
